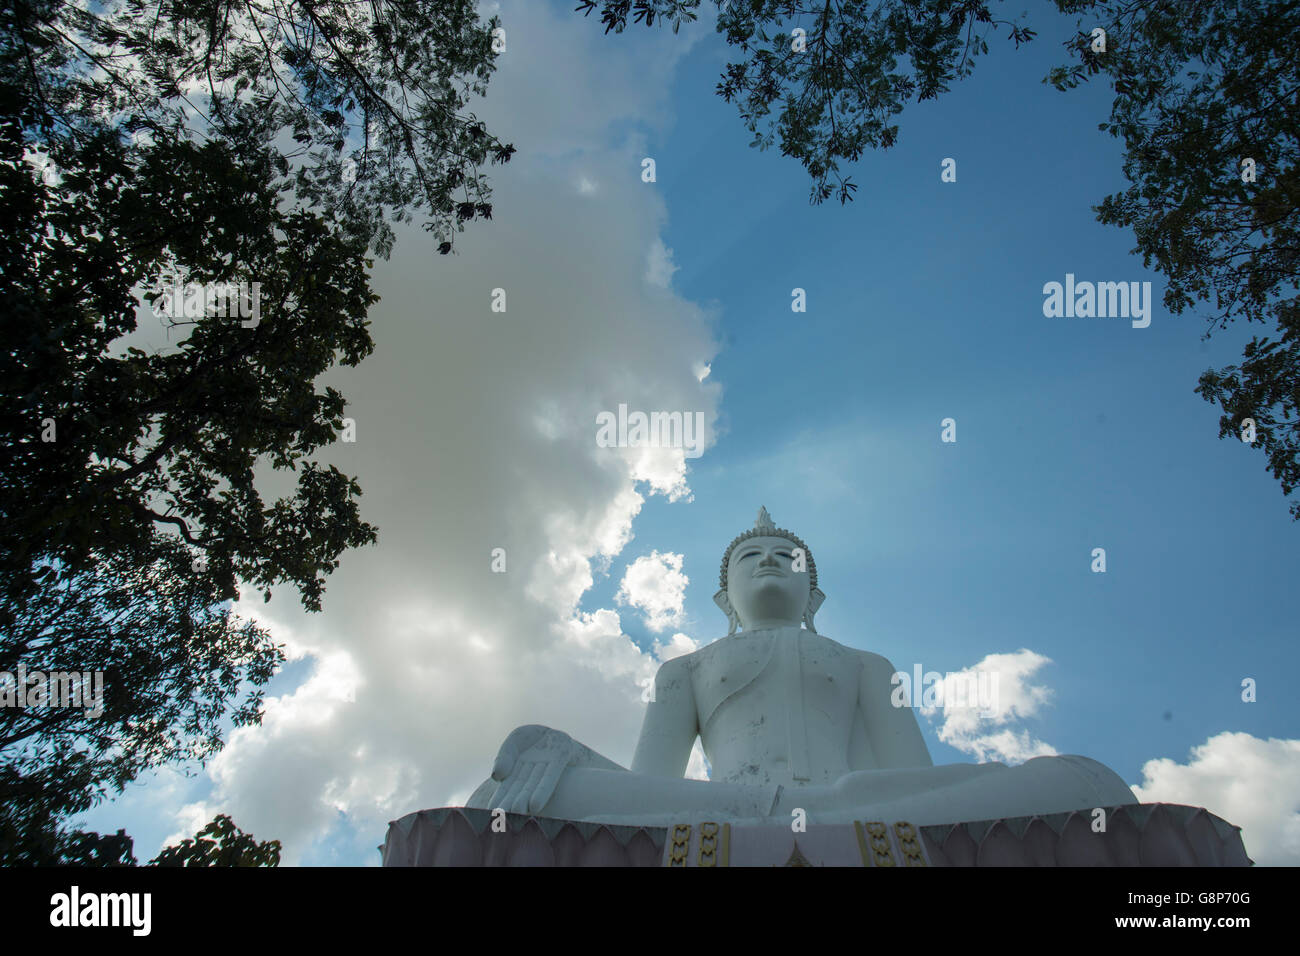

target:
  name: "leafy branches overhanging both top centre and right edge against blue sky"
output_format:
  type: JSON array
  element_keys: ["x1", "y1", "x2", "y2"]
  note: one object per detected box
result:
[{"x1": 577, "y1": 0, "x2": 1300, "y2": 520}]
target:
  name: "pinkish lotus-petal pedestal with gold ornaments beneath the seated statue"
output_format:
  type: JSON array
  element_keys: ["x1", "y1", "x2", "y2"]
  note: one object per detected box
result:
[{"x1": 380, "y1": 804, "x2": 1253, "y2": 866}]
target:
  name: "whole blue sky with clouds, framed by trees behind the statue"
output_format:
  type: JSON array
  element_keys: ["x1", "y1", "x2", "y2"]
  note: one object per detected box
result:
[{"x1": 78, "y1": 3, "x2": 1300, "y2": 865}]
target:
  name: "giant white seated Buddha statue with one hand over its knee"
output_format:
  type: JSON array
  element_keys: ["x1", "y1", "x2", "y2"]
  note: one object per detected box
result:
[{"x1": 468, "y1": 509, "x2": 1136, "y2": 826}]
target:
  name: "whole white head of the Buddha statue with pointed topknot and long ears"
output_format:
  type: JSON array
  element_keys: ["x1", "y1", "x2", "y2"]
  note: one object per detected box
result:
[{"x1": 714, "y1": 507, "x2": 826, "y2": 635}]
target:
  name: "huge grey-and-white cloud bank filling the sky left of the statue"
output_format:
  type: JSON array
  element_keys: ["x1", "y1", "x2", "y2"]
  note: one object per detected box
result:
[{"x1": 104, "y1": 1, "x2": 720, "y2": 864}]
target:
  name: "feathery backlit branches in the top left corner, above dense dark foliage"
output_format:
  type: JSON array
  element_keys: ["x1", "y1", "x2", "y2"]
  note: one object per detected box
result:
[{"x1": 0, "y1": 0, "x2": 515, "y2": 255}]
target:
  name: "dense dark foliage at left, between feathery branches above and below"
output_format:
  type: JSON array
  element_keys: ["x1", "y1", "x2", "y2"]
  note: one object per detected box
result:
[{"x1": 0, "y1": 83, "x2": 376, "y2": 609}]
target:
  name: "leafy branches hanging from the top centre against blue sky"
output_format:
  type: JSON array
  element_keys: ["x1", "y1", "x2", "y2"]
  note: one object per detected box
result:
[{"x1": 577, "y1": 0, "x2": 1034, "y2": 203}]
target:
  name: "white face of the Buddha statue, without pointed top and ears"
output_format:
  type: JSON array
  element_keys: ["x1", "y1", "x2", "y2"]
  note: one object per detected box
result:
[{"x1": 727, "y1": 537, "x2": 810, "y2": 631}]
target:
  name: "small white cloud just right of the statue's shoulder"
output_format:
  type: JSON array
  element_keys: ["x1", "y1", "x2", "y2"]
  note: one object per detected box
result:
[{"x1": 913, "y1": 649, "x2": 1057, "y2": 763}]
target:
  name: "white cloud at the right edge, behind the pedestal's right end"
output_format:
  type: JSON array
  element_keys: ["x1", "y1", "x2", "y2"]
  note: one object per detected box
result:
[{"x1": 1134, "y1": 731, "x2": 1300, "y2": 866}]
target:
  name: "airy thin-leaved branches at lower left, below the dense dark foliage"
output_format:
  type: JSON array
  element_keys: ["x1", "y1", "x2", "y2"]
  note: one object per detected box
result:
[{"x1": 0, "y1": 535, "x2": 283, "y2": 864}]
